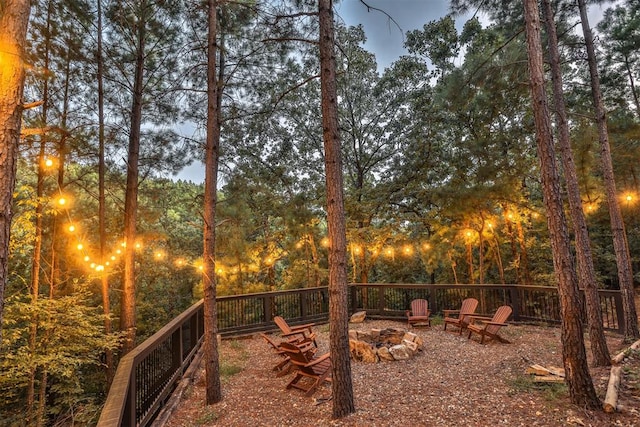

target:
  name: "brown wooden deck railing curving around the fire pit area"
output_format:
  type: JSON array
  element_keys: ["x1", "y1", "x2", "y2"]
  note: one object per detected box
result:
[{"x1": 98, "y1": 284, "x2": 623, "y2": 427}]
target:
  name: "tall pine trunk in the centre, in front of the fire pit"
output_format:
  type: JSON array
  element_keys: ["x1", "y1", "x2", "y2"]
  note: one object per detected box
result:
[{"x1": 318, "y1": 0, "x2": 355, "y2": 418}]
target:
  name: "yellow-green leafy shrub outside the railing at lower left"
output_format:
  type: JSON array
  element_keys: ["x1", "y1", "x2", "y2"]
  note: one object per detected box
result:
[{"x1": 0, "y1": 284, "x2": 119, "y2": 421}]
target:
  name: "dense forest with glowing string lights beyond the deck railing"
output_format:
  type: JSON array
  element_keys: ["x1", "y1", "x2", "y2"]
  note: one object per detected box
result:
[{"x1": 0, "y1": 0, "x2": 640, "y2": 424}]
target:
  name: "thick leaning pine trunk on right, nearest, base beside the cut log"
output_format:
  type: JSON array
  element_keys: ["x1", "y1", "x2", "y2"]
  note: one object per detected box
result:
[{"x1": 524, "y1": 0, "x2": 600, "y2": 409}]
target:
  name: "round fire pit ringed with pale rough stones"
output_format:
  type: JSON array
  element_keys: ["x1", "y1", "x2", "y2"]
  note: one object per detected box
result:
[{"x1": 349, "y1": 328, "x2": 423, "y2": 363}]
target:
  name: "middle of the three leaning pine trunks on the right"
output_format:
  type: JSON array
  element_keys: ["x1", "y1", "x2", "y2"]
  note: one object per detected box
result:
[{"x1": 542, "y1": 0, "x2": 611, "y2": 366}]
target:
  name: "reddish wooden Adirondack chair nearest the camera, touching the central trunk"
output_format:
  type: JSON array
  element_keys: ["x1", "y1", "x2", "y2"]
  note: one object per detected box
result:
[{"x1": 280, "y1": 342, "x2": 331, "y2": 397}]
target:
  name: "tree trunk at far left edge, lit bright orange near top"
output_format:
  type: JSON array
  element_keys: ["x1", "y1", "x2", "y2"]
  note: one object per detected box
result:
[{"x1": 0, "y1": 0, "x2": 31, "y2": 343}]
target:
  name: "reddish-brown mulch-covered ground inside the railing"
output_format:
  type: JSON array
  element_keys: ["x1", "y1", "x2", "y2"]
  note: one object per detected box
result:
[{"x1": 166, "y1": 308, "x2": 640, "y2": 427}]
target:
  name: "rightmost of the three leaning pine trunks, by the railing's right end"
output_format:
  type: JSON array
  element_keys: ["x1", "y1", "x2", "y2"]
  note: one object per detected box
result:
[{"x1": 578, "y1": 0, "x2": 640, "y2": 342}]
